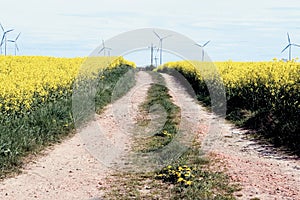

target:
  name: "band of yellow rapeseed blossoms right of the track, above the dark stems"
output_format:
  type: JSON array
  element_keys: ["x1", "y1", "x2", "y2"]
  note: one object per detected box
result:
[{"x1": 160, "y1": 59, "x2": 300, "y2": 108}]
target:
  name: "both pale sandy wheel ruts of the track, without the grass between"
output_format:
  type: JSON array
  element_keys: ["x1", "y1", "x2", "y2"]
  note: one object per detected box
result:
[{"x1": 0, "y1": 72, "x2": 300, "y2": 200}]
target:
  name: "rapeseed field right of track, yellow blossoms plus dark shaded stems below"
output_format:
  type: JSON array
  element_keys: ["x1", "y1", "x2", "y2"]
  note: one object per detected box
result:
[{"x1": 158, "y1": 59, "x2": 300, "y2": 151}]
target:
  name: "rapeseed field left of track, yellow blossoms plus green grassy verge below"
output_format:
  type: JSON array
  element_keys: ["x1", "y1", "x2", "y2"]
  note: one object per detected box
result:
[{"x1": 0, "y1": 56, "x2": 134, "y2": 178}]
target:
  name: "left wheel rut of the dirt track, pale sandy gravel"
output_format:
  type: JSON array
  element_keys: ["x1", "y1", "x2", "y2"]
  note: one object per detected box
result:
[{"x1": 0, "y1": 72, "x2": 152, "y2": 200}]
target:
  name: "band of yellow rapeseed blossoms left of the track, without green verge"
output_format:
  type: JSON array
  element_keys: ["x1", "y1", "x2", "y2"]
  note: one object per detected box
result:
[{"x1": 0, "y1": 56, "x2": 134, "y2": 112}]
